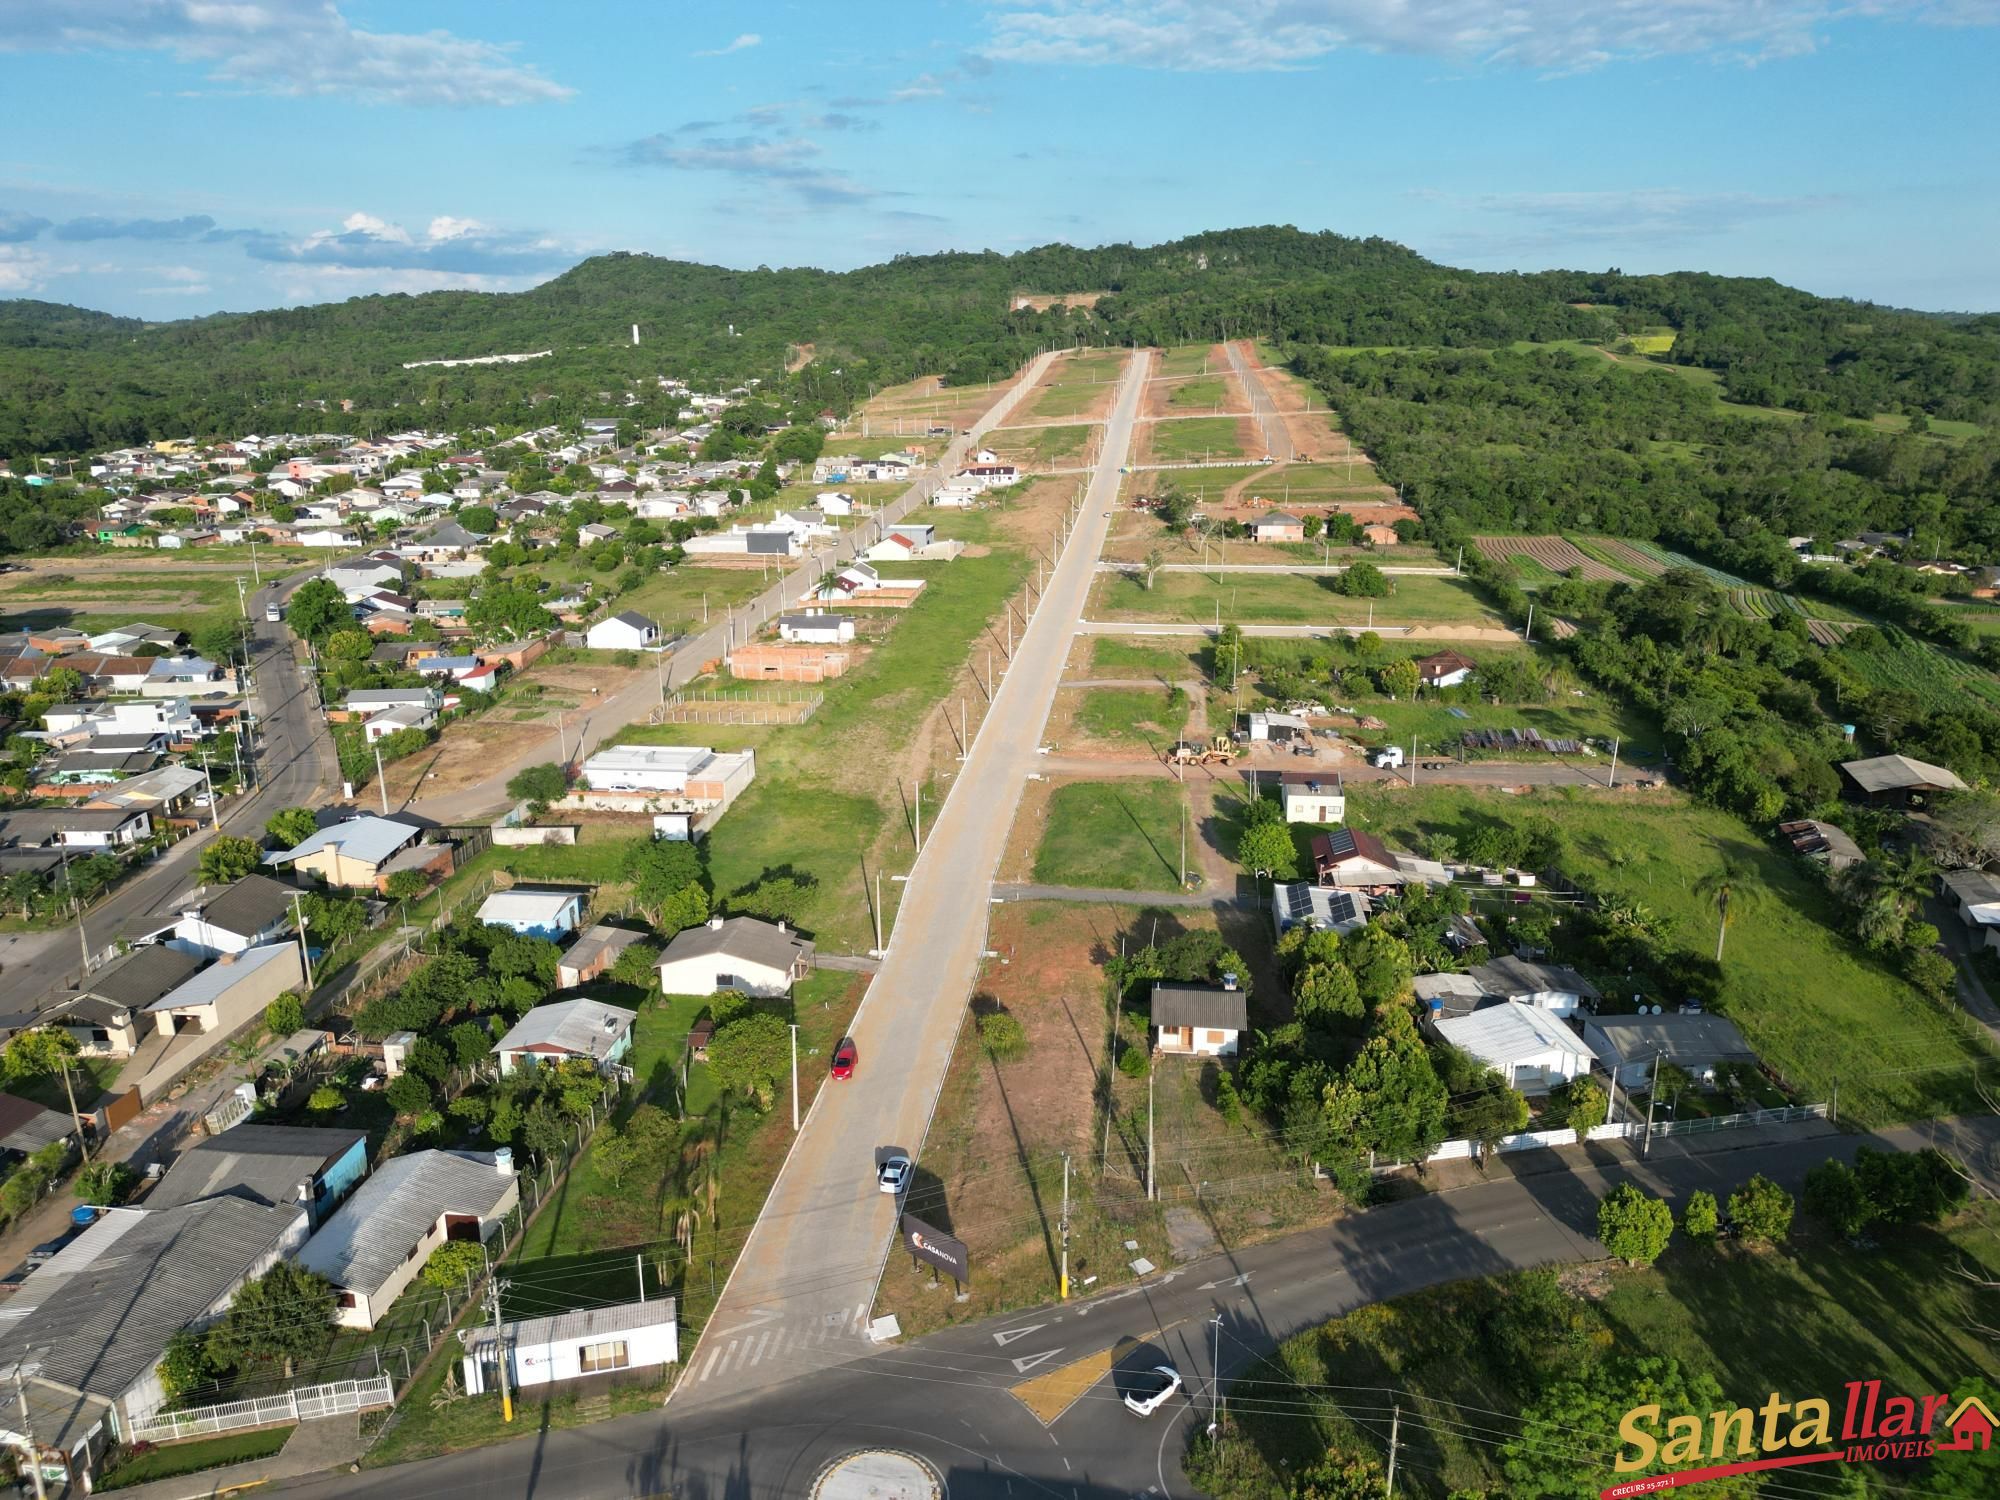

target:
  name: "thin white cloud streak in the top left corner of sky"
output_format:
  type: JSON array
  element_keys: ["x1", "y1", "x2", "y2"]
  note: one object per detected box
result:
[{"x1": 0, "y1": 0, "x2": 576, "y2": 106}]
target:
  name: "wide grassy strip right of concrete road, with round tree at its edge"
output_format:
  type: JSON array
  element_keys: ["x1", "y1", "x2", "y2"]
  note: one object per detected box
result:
[{"x1": 1086, "y1": 572, "x2": 1504, "y2": 628}]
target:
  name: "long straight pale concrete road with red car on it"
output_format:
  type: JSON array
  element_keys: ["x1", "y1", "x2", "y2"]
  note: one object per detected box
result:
[{"x1": 676, "y1": 354, "x2": 1150, "y2": 1404}]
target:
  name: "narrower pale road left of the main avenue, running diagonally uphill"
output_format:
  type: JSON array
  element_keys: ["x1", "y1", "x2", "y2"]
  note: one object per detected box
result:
[{"x1": 404, "y1": 354, "x2": 1056, "y2": 822}]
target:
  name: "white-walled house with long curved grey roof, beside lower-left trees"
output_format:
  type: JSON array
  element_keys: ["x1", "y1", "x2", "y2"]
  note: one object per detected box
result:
[{"x1": 298, "y1": 1150, "x2": 520, "y2": 1330}]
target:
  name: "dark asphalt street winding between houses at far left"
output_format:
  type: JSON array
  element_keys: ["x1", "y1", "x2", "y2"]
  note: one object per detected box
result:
[{"x1": 0, "y1": 572, "x2": 338, "y2": 1010}]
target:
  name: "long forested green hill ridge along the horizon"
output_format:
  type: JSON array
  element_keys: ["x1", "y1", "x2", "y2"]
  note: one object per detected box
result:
[{"x1": 0, "y1": 228, "x2": 2000, "y2": 458}]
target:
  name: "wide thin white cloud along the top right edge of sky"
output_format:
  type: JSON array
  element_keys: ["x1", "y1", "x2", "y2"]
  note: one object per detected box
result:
[{"x1": 984, "y1": 0, "x2": 2000, "y2": 72}]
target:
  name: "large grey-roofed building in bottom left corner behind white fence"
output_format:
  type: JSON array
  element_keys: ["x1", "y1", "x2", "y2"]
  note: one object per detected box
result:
[{"x1": 0, "y1": 1194, "x2": 308, "y2": 1490}]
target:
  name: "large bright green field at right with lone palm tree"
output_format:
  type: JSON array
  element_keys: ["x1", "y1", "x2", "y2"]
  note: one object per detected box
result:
[{"x1": 1348, "y1": 786, "x2": 1990, "y2": 1126}]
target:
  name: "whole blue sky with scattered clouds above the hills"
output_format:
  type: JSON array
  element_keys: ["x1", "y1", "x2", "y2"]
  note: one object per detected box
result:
[{"x1": 0, "y1": 0, "x2": 2000, "y2": 318}]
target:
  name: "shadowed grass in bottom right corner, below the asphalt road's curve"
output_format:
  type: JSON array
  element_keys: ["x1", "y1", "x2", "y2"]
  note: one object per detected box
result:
[{"x1": 1202, "y1": 1216, "x2": 2000, "y2": 1500}]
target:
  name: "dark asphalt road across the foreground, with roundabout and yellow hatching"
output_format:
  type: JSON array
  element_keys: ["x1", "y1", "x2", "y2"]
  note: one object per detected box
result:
[{"x1": 270, "y1": 1120, "x2": 2000, "y2": 1500}]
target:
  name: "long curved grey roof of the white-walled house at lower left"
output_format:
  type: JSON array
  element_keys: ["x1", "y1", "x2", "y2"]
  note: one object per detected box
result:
[{"x1": 300, "y1": 1150, "x2": 514, "y2": 1296}]
